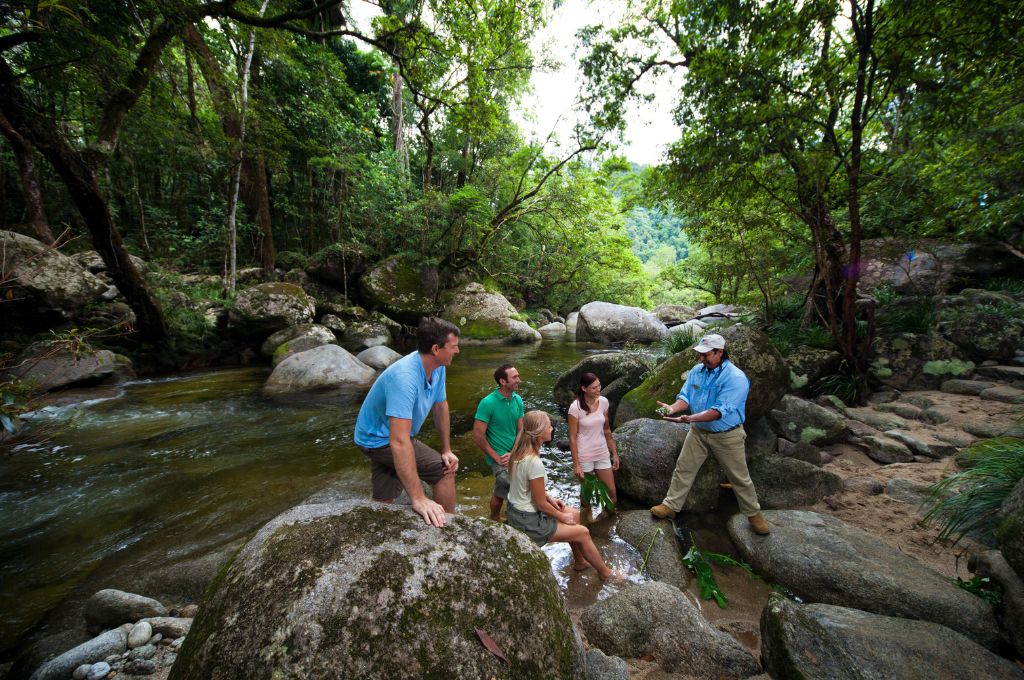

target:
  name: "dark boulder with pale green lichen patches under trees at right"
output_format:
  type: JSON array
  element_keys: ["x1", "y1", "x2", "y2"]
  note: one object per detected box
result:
[{"x1": 869, "y1": 333, "x2": 974, "y2": 390}]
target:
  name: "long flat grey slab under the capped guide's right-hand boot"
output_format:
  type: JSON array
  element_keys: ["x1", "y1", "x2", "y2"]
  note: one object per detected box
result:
[{"x1": 727, "y1": 510, "x2": 1000, "y2": 649}]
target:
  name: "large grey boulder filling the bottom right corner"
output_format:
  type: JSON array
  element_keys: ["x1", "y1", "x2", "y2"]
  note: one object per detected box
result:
[{"x1": 761, "y1": 594, "x2": 1024, "y2": 680}]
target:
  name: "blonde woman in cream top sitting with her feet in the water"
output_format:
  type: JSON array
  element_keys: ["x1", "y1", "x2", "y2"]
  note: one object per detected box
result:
[{"x1": 508, "y1": 411, "x2": 622, "y2": 580}]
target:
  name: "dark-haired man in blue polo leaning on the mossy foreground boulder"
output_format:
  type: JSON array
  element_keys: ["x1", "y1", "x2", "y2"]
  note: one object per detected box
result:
[{"x1": 355, "y1": 316, "x2": 459, "y2": 526}]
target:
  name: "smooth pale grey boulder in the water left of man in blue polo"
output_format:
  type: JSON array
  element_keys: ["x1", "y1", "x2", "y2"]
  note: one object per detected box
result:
[{"x1": 263, "y1": 345, "x2": 377, "y2": 394}]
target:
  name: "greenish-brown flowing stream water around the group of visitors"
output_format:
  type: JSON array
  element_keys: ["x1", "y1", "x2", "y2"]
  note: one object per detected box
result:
[{"x1": 0, "y1": 341, "x2": 770, "y2": 656}]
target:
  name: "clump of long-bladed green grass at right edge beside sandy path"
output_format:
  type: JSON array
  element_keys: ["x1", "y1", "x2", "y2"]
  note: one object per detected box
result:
[{"x1": 921, "y1": 437, "x2": 1024, "y2": 545}]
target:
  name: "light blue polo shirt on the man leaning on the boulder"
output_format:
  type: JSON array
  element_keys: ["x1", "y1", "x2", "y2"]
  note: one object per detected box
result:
[{"x1": 355, "y1": 351, "x2": 447, "y2": 449}]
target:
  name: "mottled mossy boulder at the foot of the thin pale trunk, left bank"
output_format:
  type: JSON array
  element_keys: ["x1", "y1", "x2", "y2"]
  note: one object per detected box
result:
[{"x1": 228, "y1": 283, "x2": 316, "y2": 337}]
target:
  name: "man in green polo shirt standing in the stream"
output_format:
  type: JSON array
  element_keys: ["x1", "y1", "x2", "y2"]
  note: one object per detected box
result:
[{"x1": 473, "y1": 364, "x2": 525, "y2": 521}]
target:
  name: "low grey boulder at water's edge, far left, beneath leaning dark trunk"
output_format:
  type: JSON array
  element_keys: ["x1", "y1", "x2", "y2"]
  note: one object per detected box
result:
[{"x1": 6, "y1": 342, "x2": 135, "y2": 392}]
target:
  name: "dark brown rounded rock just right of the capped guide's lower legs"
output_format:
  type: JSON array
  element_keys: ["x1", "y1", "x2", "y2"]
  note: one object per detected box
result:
[{"x1": 749, "y1": 456, "x2": 843, "y2": 508}]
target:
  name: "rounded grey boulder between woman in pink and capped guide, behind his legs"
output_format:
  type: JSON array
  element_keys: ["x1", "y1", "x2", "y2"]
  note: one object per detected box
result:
[{"x1": 612, "y1": 418, "x2": 723, "y2": 512}]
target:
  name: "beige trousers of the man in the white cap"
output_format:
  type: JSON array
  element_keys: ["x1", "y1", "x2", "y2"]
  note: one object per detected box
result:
[{"x1": 664, "y1": 426, "x2": 761, "y2": 517}]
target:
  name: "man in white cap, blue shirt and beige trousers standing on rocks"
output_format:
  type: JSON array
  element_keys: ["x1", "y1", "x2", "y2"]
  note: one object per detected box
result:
[{"x1": 650, "y1": 334, "x2": 770, "y2": 535}]
